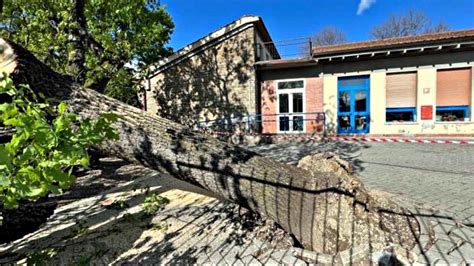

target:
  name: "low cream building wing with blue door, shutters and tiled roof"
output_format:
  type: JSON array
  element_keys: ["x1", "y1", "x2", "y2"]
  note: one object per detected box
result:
[{"x1": 257, "y1": 30, "x2": 474, "y2": 136}]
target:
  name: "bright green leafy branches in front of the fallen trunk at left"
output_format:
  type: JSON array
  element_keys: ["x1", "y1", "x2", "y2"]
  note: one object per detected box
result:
[{"x1": 0, "y1": 77, "x2": 119, "y2": 208}]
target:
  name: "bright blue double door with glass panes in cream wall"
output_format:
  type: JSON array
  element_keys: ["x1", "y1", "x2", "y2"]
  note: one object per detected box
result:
[{"x1": 337, "y1": 76, "x2": 370, "y2": 134}]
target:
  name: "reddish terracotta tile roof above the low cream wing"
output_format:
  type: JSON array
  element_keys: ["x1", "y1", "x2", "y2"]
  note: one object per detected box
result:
[{"x1": 313, "y1": 29, "x2": 474, "y2": 56}]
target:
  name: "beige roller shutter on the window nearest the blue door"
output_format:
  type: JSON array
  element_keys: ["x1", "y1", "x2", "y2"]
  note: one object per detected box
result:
[{"x1": 386, "y1": 73, "x2": 416, "y2": 108}]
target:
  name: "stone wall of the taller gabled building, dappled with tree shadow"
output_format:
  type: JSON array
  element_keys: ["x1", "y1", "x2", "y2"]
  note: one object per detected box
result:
[{"x1": 152, "y1": 31, "x2": 255, "y2": 130}]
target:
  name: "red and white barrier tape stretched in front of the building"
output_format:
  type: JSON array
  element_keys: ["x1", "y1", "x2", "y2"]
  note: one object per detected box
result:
[{"x1": 196, "y1": 131, "x2": 474, "y2": 145}]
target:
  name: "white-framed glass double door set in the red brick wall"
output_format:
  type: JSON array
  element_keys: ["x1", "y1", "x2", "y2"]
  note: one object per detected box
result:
[{"x1": 278, "y1": 92, "x2": 305, "y2": 133}]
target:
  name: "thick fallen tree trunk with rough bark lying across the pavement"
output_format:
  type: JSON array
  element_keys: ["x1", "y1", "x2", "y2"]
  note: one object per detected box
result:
[{"x1": 0, "y1": 40, "x2": 418, "y2": 254}]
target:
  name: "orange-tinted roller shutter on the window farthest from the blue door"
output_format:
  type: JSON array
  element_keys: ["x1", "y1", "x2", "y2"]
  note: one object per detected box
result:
[{"x1": 436, "y1": 68, "x2": 471, "y2": 106}]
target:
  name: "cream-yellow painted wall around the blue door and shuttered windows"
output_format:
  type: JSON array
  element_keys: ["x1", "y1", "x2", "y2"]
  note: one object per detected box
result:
[{"x1": 323, "y1": 63, "x2": 474, "y2": 135}]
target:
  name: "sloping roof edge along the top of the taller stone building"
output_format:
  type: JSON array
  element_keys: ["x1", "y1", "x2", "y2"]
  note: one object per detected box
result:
[{"x1": 149, "y1": 15, "x2": 278, "y2": 78}]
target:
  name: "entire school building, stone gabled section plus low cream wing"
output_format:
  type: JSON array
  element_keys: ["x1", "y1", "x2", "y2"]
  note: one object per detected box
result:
[{"x1": 143, "y1": 16, "x2": 474, "y2": 136}]
